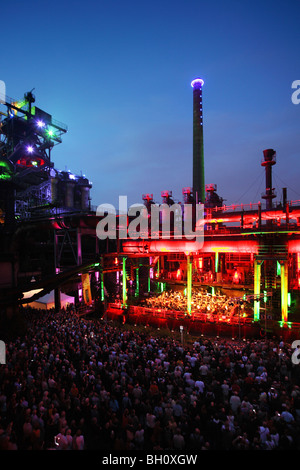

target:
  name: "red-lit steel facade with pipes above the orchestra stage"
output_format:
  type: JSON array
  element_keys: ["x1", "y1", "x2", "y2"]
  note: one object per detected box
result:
[{"x1": 115, "y1": 181, "x2": 300, "y2": 323}]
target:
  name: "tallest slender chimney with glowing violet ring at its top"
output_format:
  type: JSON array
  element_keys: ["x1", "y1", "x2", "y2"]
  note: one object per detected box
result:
[{"x1": 191, "y1": 78, "x2": 205, "y2": 204}]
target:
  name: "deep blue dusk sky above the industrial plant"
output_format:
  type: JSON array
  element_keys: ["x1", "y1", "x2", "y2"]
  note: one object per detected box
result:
[{"x1": 0, "y1": 0, "x2": 300, "y2": 207}]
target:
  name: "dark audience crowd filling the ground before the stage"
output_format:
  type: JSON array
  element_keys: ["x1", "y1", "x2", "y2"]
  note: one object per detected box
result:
[{"x1": 0, "y1": 309, "x2": 300, "y2": 452}]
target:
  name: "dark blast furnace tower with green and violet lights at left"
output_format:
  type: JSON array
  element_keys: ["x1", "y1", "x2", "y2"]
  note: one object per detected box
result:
[{"x1": 0, "y1": 92, "x2": 91, "y2": 223}]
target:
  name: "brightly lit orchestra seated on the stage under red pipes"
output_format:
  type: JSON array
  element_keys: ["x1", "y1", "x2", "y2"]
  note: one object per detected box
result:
[{"x1": 146, "y1": 289, "x2": 249, "y2": 317}]
